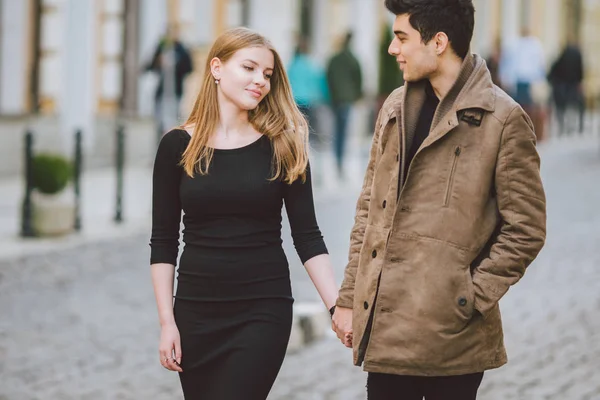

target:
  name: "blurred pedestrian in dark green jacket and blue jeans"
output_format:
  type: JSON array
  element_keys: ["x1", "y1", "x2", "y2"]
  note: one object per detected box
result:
[{"x1": 327, "y1": 32, "x2": 363, "y2": 178}]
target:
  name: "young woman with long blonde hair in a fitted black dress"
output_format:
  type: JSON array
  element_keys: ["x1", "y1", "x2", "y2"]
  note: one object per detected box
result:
[{"x1": 150, "y1": 28, "x2": 337, "y2": 400}]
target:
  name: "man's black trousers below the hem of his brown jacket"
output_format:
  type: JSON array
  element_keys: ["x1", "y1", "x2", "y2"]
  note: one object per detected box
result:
[{"x1": 367, "y1": 372, "x2": 483, "y2": 400}]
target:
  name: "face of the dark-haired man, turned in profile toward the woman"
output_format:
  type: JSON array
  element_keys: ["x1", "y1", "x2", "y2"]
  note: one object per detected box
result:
[{"x1": 388, "y1": 14, "x2": 438, "y2": 82}]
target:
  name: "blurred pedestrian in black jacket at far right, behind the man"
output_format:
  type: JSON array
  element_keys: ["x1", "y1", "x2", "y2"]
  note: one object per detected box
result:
[{"x1": 548, "y1": 38, "x2": 585, "y2": 134}]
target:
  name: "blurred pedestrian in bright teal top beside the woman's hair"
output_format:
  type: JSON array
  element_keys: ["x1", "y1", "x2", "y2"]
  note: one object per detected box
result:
[{"x1": 287, "y1": 38, "x2": 329, "y2": 181}]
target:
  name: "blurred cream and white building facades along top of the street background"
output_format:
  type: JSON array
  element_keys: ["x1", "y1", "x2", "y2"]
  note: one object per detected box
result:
[{"x1": 0, "y1": 0, "x2": 600, "y2": 175}]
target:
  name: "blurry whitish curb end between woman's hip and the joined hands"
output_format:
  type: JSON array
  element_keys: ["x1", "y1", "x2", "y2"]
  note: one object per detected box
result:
[{"x1": 287, "y1": 302, "x2": 331, "y2": 353}]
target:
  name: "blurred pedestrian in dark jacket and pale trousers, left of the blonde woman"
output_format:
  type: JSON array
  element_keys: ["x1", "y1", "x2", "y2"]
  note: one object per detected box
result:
[{"x1": 146, "y1": 25, "x2": 193, "y2": 139}]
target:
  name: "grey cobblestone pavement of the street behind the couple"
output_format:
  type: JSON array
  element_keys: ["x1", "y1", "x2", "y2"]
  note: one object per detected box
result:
[{"x1": 0, "y1": 137, "x2": 600, "y2": 400}]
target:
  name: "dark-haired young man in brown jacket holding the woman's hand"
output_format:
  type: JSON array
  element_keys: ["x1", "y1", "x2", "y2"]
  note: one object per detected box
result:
[{"x1": 333, "y1": 0, "x2": 546, "y2": 400}]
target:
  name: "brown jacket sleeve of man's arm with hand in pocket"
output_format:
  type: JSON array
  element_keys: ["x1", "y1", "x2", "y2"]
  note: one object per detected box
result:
[{"x1": 473, "y1": 106, "x2": 546, "y2": 317}]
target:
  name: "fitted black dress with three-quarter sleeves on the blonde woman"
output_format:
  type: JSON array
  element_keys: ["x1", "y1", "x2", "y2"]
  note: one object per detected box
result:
[{"x1": 150, "y1": 129, "x2": 327, "y2": 400}]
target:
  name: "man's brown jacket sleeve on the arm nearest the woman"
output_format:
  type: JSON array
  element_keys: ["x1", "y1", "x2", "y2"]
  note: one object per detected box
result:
[{"x1": 335, "y1": 107, "x2": 385, "y2": 308}]
